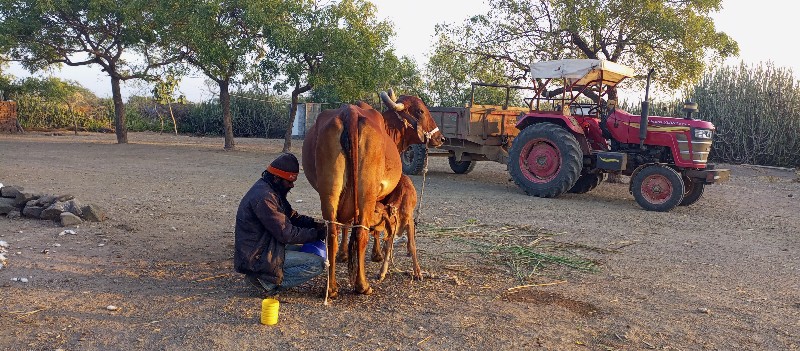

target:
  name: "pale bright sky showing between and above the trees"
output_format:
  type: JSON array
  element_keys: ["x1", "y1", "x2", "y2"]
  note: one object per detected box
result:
[{"x1": 4, "y1": 0, "x2": 800, "y2": 101}]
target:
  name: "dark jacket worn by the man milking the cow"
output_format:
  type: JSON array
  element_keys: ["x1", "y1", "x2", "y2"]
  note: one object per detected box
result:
[{"x1": 233, "y1": 178, "x2": 317, "y2": 285}]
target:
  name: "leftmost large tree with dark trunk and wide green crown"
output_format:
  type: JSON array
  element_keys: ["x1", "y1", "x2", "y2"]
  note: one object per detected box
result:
[{"x1": 0, "y1": 0, "x2": 180, "y2": 144}]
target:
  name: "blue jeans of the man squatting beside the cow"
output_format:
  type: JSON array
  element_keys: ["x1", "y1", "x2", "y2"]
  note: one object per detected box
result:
[{"x1": 252, "y1": 245, "x2": 325, "y2": 294}]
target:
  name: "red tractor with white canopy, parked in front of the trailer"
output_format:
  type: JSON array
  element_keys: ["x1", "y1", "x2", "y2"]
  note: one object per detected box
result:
[{"x1": 508, "y1": 59, "x2": 730, "y2": 211}]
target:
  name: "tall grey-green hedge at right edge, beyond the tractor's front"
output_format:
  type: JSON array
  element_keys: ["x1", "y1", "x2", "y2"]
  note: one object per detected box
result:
[{"x1": 691, "y1": 63, "x2": 800, "y2": 167}]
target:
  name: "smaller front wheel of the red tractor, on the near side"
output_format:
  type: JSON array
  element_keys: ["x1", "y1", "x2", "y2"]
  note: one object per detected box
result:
[{"x1": 631, "y1": 165, "x2": 683, "y2": 212}]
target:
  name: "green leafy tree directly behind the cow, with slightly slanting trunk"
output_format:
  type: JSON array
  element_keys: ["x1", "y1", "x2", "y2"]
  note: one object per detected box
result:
[{"x1": 260, "y1": 0, "x2": 397, "y2": 152}]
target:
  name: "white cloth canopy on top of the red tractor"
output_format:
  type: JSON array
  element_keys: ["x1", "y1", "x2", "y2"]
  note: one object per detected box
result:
[{"x1": 531, "y1": 59, "x2": 635, "y2": 86}]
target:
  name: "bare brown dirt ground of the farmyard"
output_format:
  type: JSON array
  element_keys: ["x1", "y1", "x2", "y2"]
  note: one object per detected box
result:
[{"x1": 0, "y1": 132, "x2": 800, "y2": 350}]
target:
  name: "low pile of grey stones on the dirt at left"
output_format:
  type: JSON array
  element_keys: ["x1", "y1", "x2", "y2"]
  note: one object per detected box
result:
[{"x1": 0, "y1": 184, "x2": 106, "y2": 227}]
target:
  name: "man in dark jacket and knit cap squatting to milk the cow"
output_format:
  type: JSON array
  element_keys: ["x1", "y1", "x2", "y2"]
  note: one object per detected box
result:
[{"x1": 233, "y1": 153, "x2": 327, "y2": 295}]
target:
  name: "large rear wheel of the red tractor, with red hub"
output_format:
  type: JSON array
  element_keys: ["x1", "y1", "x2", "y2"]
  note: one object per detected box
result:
[{"x1": 508, "y1": 123, "x2": 583, "y2": 197}]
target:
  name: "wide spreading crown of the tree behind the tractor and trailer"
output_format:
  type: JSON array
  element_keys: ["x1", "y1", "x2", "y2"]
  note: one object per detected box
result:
[{"x1": 437, "y1": 0, "x2": 739, "y2": 97}]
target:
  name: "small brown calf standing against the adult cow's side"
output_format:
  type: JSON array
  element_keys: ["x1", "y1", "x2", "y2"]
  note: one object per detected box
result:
[{"x1": 371, "y1": 174, "x2": 422, "y2": 281}]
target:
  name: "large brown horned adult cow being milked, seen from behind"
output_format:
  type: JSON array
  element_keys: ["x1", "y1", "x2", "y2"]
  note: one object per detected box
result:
[{"x1": 303, "y1": 93, "x2": 443, "y2": 297}]
